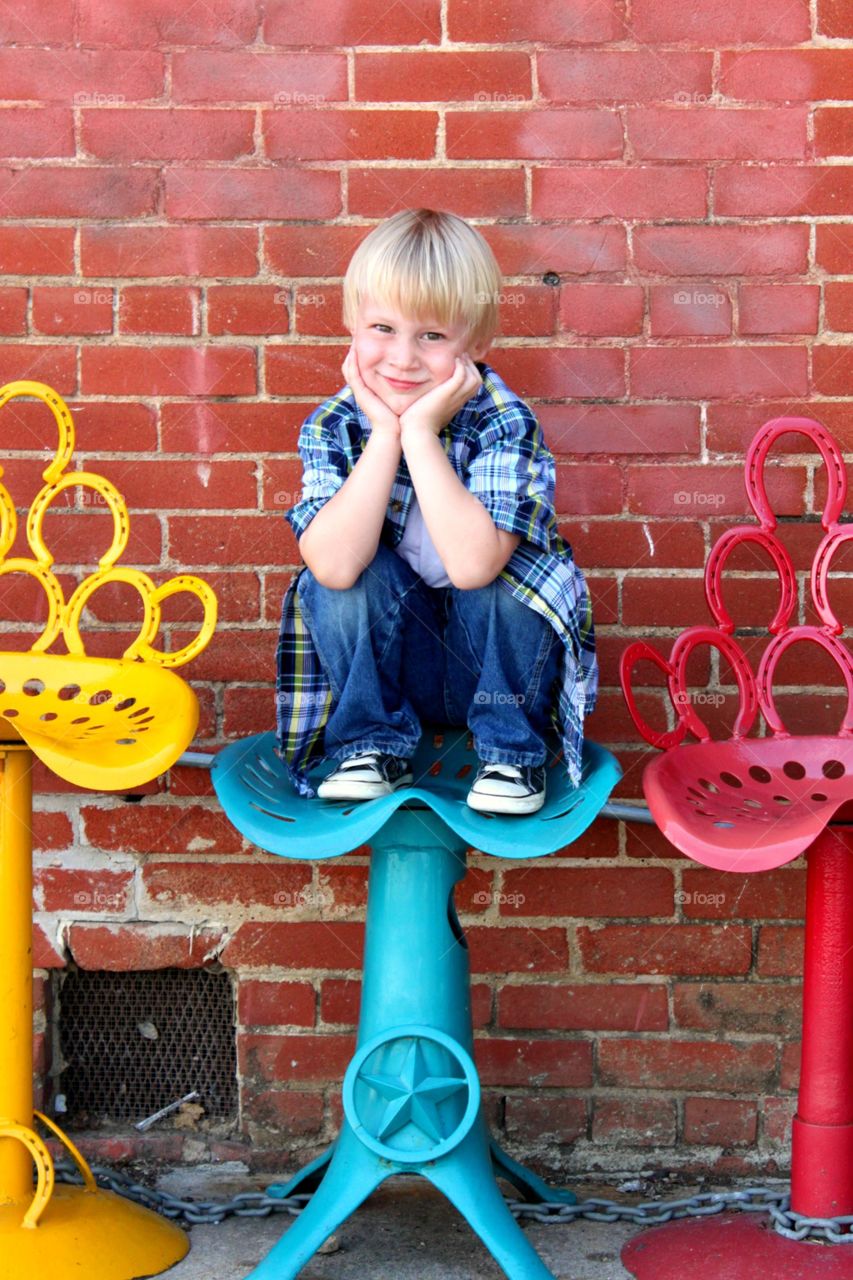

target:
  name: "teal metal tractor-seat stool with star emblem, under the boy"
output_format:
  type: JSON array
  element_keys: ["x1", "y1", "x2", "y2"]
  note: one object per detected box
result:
[{"x1": 211, "y1": 730, "x2": 620, "y2": 1280}]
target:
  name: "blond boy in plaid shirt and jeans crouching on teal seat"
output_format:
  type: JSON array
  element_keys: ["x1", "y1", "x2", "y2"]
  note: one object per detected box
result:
[{"x1": 277, "y1": 209, "x2": 597, "y2": 814}]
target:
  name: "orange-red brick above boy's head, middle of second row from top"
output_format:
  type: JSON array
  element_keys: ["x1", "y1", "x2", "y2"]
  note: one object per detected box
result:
[{"x1": 355, "y1": 49, "x2": 530, "y2": 102}]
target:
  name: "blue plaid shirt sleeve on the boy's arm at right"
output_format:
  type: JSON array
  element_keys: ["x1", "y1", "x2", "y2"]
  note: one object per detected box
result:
[{"x1": 465, "y1": 401, "x2": 556, "y2": 550}]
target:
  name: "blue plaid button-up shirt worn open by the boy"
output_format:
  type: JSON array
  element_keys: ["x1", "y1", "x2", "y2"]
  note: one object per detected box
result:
[{"x1": 275, "y1": 364, "x2": 598, "y2": 796}]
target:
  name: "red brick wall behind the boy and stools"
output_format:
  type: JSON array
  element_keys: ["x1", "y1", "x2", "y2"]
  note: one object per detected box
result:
[{"x1": 0, "y1": 0, "x2": 853, "y2": 1169}]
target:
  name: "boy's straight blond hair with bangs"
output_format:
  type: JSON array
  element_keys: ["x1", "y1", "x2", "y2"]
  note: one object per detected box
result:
[{"x1": 343, "y1": 209, "x2": 501, "y2": 348}]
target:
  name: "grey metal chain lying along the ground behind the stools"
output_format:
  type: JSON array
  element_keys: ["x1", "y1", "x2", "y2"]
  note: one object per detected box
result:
[{"x1": 56, "y1": 1161, "x2": 853, "y2": 1244}]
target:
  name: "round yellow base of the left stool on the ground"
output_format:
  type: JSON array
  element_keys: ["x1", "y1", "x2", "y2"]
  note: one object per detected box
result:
[{"x1": 0, "y1": 1184, "x2": 190, "y2": 1280}]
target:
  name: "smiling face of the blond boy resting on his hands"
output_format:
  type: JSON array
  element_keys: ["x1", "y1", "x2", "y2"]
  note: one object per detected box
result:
[{"x1": 352, "y1": 298, "x2": 487, "y2": 413}]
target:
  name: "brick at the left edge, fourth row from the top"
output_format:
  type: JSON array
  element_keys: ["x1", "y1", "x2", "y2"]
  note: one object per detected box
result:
[{"x1": 0, "y1": 165, "x2": 156, "y2": 218}]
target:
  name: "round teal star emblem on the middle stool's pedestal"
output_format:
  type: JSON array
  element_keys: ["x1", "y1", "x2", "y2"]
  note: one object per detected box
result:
[{"x1": 345, "y1": 1027, "x2": 479, "y2": 1160}]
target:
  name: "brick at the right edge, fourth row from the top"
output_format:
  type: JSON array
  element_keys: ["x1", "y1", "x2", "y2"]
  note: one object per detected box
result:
[{"x1": 715, "y1": 164, "x2": 853, "y2": 218}]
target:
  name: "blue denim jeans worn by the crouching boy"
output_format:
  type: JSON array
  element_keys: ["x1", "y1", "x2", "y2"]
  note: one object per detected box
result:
[{"x1": 297, "y1": 543, "x2": 562, "y2": 764}]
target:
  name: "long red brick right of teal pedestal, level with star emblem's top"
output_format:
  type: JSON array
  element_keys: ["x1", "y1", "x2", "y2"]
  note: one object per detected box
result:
[{"x1": 497, "y1": 983, "x2": 669, "y2": 1032}]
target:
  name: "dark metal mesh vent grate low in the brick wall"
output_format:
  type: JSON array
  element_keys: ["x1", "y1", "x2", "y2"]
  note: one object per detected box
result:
[{"x1": 54, "y1": 969, "x2": 237, "y2": 1126}]
